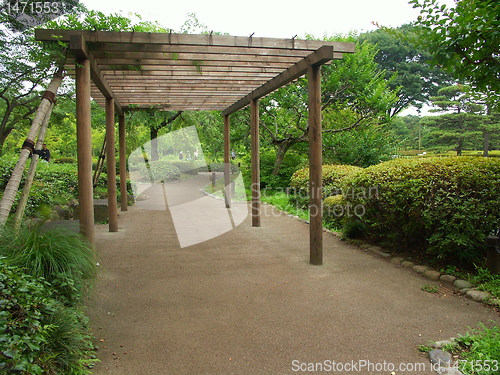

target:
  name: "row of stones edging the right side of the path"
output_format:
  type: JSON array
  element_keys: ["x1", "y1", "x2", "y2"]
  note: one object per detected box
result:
[{"x1": 284, "y1": 203, "x2": 500, "y2": 375}]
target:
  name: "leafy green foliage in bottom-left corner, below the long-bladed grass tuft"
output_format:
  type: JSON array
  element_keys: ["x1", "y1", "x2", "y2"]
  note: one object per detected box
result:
[{"x1": 0, "y1": 258, "x2": 96, "y2": 375}]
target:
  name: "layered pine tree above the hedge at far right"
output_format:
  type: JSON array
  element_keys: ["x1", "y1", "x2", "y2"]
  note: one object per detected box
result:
[{"x1": 426, "y1": 85, "x2": 484, "y2": 156}]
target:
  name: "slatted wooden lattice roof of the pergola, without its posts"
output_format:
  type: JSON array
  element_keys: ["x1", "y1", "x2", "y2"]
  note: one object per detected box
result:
[{"x1": 36, "y1": 29, "x2": 354, "y2": 114}]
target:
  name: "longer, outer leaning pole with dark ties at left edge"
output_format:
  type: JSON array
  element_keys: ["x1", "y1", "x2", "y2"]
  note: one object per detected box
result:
[{"x1": 0, "y1": 68, "x2": 63, "y2": 225}]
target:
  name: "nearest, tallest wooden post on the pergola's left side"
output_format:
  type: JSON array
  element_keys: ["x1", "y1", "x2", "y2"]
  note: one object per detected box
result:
[{"x1": 75, "y1": 59, "x2": 94, "y2": 246}]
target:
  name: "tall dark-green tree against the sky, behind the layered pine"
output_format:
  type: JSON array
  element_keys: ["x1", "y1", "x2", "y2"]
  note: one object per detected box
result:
[{"x1": 359, "y1": 25, "x2": 454, "y2": 117}]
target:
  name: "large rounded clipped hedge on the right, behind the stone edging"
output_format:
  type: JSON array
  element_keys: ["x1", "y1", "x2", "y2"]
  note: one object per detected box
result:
[{"x1": 344, "y1": 157, "x2": 500, "y2": 263}]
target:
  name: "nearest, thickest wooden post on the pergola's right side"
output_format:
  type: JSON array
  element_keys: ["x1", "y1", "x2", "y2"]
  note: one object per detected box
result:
[{"x1": 308, "y1": 65, "x2": 323, "y2": 265}]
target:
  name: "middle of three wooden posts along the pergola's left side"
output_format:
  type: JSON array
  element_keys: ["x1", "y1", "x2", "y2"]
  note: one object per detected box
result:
[{"x1": 106, "y1": 99, "x2": 118, "y2": 232}]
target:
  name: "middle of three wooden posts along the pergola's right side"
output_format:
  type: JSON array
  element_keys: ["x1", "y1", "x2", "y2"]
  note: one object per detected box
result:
[{"x1": 250, "y1": 99, "x2": 260, "y2": 227}]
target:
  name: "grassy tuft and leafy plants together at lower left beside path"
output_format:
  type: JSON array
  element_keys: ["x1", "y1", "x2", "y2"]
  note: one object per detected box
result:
[{"x1": 0, "y1": 226, "x2": 96, "y2": 375}]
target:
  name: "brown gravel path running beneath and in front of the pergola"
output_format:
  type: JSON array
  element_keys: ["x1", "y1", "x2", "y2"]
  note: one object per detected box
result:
[{"x1": 88, "y1": 197, "x2": 500, "y2": 375}]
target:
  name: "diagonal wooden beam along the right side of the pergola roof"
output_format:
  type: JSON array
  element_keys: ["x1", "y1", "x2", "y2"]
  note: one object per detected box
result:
[{"x1": 222, "y1": 45, "x2": 334, "y2": 116}]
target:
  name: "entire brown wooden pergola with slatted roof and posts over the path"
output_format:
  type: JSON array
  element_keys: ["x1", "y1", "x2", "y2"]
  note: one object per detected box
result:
[{"x1": 36, "y1": 29, "x2": 354, "y2": 264}]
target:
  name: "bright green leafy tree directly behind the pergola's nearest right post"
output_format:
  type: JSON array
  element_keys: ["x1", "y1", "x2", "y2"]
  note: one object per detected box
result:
[{"x1": 261, "y1": 39, "x2": 397, "y2": 175}]
